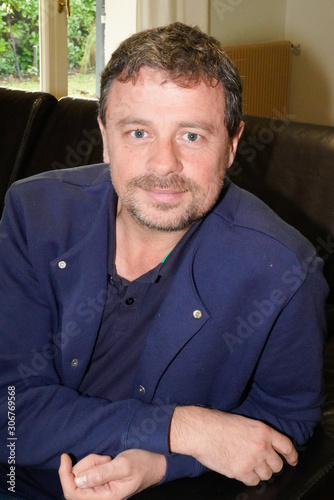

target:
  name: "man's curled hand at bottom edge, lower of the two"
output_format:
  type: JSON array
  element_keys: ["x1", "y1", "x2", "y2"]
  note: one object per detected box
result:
[{"x1": 59, "y1": 450, "x2": 166, "y2": 500}]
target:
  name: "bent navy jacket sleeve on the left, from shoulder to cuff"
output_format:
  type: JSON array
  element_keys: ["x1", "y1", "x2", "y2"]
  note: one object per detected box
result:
[{"x1": 0, "y1": 192, "x2": 174, "y2": 468}]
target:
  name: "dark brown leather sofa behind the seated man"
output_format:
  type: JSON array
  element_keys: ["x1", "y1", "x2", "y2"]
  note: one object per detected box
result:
[{"x1": 0, "y1": 88, "x2": 334, "y2": 500}]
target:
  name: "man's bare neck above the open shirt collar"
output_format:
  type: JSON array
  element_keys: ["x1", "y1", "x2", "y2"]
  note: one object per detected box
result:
[{"x1": 115, "y1": 210, "x2": 187, "y2": 281}]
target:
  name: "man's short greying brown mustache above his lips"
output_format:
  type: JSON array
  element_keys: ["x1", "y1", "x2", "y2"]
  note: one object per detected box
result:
[{"x1": 127, "y1": 174, "x2": 199, "y2": 191}]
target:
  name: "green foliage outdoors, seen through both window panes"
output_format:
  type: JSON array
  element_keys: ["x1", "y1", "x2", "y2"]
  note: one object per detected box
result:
[{"x1": 0, "y1": 0, "x2": 95, "y2": 76}]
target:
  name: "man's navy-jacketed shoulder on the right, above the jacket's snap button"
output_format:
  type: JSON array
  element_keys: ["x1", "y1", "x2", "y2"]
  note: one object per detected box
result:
[{"x1": 191, "y1": 183, "x2": 324, "y2": 311}]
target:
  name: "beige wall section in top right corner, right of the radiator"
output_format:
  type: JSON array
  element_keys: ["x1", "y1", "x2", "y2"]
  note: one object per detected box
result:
[{"x1": 285, "y1": 0, "x2": 334, "y2": 125}]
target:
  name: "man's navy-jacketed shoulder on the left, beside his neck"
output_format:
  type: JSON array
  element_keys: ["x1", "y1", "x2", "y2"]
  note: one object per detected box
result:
[{"x1": 2, "y1": 164, "x2": 116, "y2": 242}]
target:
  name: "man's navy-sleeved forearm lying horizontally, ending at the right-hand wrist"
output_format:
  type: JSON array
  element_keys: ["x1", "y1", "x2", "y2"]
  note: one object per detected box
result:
[{"x1": 0, "y1": 385, "x2": 174, "y2": 469}]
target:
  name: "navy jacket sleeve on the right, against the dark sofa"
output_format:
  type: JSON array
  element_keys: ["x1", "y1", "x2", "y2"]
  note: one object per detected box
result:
[{"x1": 234, "y1": 257, "x2": 328, "y2": 446}]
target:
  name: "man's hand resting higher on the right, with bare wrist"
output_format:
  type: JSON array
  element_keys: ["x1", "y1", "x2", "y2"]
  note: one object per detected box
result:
[{"x1": 170, "y1": 406, "x2": 298, "y2": 486}]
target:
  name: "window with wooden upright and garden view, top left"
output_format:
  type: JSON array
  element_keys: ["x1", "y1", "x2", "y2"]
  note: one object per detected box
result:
[{"x1": 0, "y1": 0, "x2": 98, "y2": 98}]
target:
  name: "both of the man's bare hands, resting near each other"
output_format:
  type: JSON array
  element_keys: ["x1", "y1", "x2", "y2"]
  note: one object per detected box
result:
[{"x1": 59, "y1": 406, "x2": 298, "y2": 500}]
